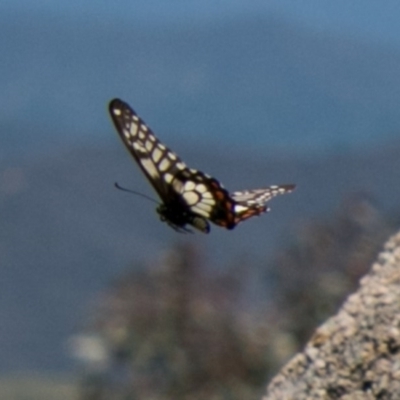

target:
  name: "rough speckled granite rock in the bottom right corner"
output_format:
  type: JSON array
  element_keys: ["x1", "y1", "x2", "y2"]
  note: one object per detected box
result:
[{"x1": 263, "y1": 232, "x2": 400, "y2": 400}]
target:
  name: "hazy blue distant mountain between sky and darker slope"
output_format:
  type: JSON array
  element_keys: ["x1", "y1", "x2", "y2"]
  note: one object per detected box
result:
[{"x1": 0, "y1": 12, "x2": 400, "y2": 157}]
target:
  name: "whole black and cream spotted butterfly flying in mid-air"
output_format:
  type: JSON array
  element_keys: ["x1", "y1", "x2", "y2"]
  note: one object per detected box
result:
[{"x1": 109, "y1": 99, "x2": 295, "y2": 233}]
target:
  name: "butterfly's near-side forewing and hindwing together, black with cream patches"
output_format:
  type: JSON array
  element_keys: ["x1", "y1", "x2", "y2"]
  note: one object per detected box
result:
[{"x1": 109, "y1": 99, "x2": 234, "y2": 231}]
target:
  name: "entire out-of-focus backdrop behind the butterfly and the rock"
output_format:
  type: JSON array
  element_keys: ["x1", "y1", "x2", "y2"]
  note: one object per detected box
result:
[{"x1": 0, "y1": 0, "x2": 400, "y2": 400}]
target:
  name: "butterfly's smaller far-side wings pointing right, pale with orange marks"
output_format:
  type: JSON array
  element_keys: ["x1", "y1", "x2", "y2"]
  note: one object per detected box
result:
[{"x1": 231, "y1": 185, "x2": 296, "y2": 224}]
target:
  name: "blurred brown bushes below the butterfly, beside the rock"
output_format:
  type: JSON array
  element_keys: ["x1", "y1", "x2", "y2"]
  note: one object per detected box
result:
[{"x1": 71, "y1": 200, "x2": 400, "y2": 400}]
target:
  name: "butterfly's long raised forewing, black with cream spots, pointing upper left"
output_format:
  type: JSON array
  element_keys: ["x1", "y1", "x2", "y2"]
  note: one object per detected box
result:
[{"x1": 109, "y1": 99, "x2": 187, "y2": 202}]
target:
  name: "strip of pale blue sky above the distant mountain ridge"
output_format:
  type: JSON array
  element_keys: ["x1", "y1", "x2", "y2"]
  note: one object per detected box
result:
[{"x1": 4, "y1": 0, "x2": 400, "y2": 45}]
